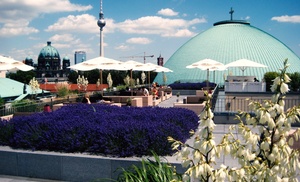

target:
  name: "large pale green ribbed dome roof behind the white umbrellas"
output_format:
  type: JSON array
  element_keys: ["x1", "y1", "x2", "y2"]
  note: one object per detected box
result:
[{"x1": 154, "y1": 20, "x2": 300, "y2": 84}]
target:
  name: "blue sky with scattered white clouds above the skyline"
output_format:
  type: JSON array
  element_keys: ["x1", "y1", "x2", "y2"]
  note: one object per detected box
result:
[{"x1": 0, "y1": 0, "x2": 300, "y2": 65}]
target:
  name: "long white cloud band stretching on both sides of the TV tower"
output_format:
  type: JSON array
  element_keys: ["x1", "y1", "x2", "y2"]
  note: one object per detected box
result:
[{"x1": 46, "y1": 14, "x2": 206, "y2": 37}]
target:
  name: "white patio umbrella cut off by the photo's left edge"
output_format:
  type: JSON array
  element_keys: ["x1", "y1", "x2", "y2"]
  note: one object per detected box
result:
[{"x1": 0, "y1": 55, "x2": 34, "y2": 71}]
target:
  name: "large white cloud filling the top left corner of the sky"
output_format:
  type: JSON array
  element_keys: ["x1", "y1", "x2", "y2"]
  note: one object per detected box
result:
[{"x1": 0, "y1": 0, "x2": 92, "y2": 37}]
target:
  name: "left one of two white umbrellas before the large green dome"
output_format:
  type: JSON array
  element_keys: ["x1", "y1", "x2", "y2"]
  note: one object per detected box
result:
[{"x1": 186, "y1": 59, "x2": 226, "y2": 87}]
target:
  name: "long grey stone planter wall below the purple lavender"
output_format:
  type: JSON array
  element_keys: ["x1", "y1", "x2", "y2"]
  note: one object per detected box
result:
[{"x1": 0, "y1": 146, "x2": 184, "y2": 182}]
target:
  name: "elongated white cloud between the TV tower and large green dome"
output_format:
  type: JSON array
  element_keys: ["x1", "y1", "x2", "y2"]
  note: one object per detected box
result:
[{"x1": 117, "y1": 16, "x2": 206, "y2": 37}]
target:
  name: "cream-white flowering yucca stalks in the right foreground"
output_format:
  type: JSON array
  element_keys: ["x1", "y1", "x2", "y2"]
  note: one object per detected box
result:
[{"x1": 168, "y1": 60, "x2": 300, "y2": 182}]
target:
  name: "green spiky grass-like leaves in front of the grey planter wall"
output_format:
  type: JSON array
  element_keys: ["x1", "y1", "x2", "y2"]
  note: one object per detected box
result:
[{"x1": 117, "y1": 152, "x2": 181, "y2": 182}]
